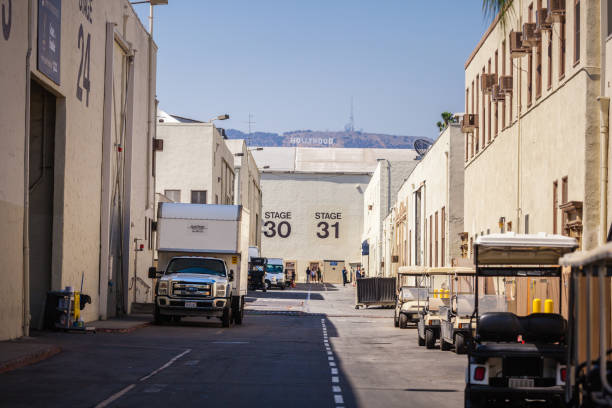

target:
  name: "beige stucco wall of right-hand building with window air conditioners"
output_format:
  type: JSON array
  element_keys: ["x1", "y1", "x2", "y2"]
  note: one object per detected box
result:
[{"x1": 465, "y1": 2, "x2": 599, "y2": 248}]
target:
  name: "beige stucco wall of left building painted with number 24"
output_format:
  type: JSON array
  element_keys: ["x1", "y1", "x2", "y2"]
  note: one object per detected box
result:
[{"x1": 0, "y1": 0, "x2": 156, "y2": 339}]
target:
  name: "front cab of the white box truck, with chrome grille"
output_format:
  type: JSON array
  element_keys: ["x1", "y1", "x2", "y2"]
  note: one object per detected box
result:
[{"x1": 149, "y1": 256, "x2": 234, "y2": 327}]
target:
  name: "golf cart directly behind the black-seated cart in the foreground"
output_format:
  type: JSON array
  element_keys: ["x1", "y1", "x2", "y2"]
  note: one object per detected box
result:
[{"x1": 440, "y1": 267, "x2": 474, "y2": 354}]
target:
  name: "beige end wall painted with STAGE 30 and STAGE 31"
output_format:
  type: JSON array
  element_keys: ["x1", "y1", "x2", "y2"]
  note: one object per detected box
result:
[{"x1": 261, "y1": 172, "x2": 370, "y2": 281}]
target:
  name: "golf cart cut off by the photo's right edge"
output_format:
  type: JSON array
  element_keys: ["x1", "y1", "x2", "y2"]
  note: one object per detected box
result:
[{"x1": 560, "y1": 243, "x2": 612, "y2": 407}]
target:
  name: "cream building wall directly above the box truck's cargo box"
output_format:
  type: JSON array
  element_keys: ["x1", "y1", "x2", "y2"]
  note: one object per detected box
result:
[{"x1": 155, "y1": 123, "x2": 234, "y2": 204}]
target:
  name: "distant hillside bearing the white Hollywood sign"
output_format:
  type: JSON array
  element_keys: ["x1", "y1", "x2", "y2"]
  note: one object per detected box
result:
[{"x1": 225, "y1": 129, "x2": 428, "y2": 149}]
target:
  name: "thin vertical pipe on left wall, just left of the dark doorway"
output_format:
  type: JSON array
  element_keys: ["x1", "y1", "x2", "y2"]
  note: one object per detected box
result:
[{"x1": 23, "y1": 0, "x2": 34, "y2": 337}]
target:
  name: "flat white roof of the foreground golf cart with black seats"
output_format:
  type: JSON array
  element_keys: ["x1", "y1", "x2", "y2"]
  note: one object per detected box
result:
[{"x1": 474, "y1": 232, "x2": 578, "y2": 267}]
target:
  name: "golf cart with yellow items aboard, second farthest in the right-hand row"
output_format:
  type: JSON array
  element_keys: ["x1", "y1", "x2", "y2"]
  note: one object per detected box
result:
[{"x1": 417, "y1": 268, "x2": 453, "y2": 349}]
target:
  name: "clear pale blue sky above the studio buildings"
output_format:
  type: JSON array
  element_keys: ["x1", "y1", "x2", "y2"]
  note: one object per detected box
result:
[{"x1": 134, "y1": 0, "x2": 490, "y2": 138}]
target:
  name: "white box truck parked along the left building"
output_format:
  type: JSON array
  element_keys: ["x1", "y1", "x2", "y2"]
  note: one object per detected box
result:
[{"x1": 149, "y1": 203, "x2": 249, "y2": 327}]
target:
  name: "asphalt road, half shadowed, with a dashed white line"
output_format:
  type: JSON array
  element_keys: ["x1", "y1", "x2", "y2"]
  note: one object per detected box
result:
[{"x1": 0, "y1": 285, "x2": 466, "y2": 408}]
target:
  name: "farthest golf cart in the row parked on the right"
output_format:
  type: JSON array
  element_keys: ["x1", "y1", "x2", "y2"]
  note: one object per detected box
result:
[{"x1": 393, "y1": 266, "x2": 427, "y2": 329}]
